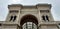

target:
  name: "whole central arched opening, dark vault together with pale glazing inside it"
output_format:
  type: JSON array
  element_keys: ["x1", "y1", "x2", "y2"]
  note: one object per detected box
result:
[{"x1": 20, "y1": 15, "x2": 38, "y2": 29}]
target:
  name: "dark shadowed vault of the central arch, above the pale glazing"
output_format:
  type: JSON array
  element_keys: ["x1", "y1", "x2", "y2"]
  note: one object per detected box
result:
[{"x1": 20, "y1": 15, "x2": 38, "y2": 25}]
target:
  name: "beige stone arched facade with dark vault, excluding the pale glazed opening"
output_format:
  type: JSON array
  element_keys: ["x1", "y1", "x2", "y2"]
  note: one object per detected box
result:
[{"x1": 0, "y1": 4, "x2": 60, "y2": 29}]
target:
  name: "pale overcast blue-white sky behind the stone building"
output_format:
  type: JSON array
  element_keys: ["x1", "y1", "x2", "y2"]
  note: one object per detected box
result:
[{"x1": 0, "y1": 0, "x2": 60, "y2": 21}]
